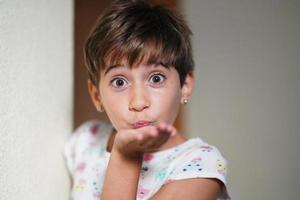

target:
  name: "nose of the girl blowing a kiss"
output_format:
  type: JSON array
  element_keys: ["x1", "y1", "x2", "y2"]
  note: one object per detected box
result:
[{"x1": 128, "y1": 87, "x2": 150, "y2": 112}]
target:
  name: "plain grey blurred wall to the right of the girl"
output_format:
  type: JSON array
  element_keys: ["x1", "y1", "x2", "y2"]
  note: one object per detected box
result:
[{"x1": 182, "y1": 0, "x2": 300, "y2": 200}]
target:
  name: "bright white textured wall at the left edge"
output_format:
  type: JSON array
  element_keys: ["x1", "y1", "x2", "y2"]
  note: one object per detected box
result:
[{"x1": 0, "y1": 0, "x2": 73, "y2": 200}]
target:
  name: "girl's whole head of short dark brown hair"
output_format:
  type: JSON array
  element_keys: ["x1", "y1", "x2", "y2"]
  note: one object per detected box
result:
[{"x1": 84, "y1": 0, "x2": 194, "y2": 86}]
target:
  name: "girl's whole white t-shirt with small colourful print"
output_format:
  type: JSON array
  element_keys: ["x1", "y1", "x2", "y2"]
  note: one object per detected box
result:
[{"x1": 64, "y1": 120, "x2": 230, "y2": 200}]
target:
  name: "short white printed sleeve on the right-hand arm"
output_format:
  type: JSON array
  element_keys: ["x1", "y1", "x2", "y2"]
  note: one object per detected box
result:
[{"x1": 167, "y1": 144, "x2": 230, "y2": 199}]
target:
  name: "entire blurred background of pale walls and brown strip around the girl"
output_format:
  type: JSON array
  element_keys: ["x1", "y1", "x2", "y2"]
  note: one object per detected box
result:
[{"x1": 0, "y1": 0, "x2": 300, "y2": 200}]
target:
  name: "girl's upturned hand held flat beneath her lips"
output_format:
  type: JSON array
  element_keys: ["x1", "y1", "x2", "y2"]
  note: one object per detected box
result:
[{"x1": 113, "y1": 123, "x2": 177, "y2": 157}]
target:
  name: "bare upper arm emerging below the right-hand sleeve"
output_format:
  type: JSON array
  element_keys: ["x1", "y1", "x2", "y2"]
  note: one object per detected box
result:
[{"x1": 151, "y1": 178, "x2": 222, "y2": 200}]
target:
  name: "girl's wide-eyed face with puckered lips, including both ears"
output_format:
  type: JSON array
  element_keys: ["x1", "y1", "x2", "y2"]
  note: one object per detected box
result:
[{"x1": 89, "y1": 63, "x2": 194, "y2": 130}]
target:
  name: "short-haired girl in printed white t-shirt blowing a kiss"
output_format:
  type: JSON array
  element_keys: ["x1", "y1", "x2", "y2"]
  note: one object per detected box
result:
[{"x1": 64, "y1": 0, "x2": 229, "y2": 200}]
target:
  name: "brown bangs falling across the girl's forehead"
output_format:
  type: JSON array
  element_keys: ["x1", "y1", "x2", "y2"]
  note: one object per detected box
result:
[{"x1": 100, "y1": 38, "x2": 179, "y2": 70}]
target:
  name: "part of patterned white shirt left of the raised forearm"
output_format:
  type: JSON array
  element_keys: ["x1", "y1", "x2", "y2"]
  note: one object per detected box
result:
[{"x1": 63, "y1": 120, "x2": 112, "y2": 200}]
